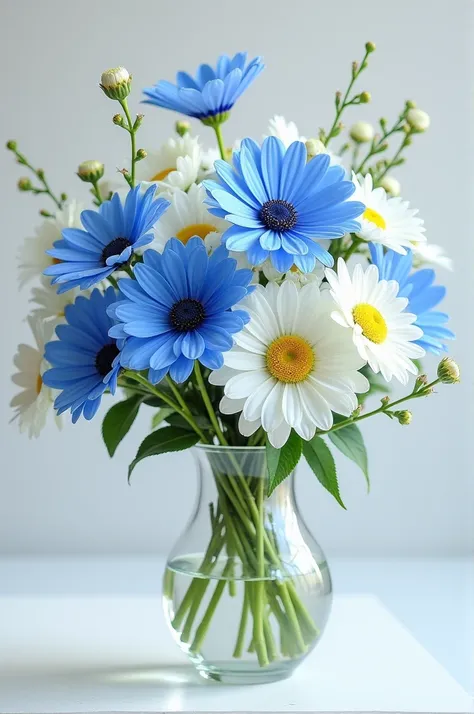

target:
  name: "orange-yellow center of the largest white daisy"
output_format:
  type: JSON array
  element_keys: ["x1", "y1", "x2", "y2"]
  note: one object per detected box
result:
[{"x1": 266, "y1": 335, "x2": 315, "y2": 384}]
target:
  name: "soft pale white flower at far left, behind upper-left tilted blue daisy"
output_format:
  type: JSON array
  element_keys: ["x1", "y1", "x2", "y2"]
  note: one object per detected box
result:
[{"x1": 18, "y1": 201, "x2": 84, "y2": 288}]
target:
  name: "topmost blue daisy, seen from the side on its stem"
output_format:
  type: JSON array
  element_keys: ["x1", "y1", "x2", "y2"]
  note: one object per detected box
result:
[{"x1": 143, "y1": 52, "x2": 265, "y2": 123}]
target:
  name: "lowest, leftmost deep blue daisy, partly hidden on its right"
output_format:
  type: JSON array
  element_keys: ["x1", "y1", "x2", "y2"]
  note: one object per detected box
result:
[{"x1": 43, "y1": 287, "x2": 121, "y2": 424}]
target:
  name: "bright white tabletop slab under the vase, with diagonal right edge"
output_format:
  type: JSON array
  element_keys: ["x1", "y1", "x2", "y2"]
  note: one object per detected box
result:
[{"x1": 0, "y1": 570, "x2": 474, "y2": 714}]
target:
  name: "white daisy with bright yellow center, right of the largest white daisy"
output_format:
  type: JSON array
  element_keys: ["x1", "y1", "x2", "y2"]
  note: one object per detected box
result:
[{"x1": 326, "y1": 258, "x2": 425, "y2": 384}]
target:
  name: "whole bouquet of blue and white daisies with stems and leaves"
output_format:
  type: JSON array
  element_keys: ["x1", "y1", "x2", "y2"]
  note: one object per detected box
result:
[{"x1": 7, "y1": 42, "x2": 459, "y2": 680}]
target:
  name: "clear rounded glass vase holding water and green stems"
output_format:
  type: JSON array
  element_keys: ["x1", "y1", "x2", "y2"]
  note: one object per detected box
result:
[{"x1": 163, "y1": 446, "x2": 332, "y2": 684}]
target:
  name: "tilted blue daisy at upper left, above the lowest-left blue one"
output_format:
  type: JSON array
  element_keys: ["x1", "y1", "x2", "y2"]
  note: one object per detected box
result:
[{"x1": 44, "y1": 185, "x2": 170, "y2": 293}]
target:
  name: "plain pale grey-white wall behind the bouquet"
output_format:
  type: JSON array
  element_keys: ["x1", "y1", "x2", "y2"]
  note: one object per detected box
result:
[{"x1": 0, "y1": 0, "x2": 474, "y2": 556}]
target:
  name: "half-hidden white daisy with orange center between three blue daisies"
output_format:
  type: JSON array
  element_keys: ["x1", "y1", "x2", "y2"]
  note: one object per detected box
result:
[{"x1": 150, "y1": 184, "x2": 230, "y2": 253}]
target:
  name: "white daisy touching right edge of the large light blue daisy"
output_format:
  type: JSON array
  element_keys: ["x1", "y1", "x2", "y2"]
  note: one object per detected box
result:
[{"x1": 351, "y1": 173, "x2": 426, "y2": 255}]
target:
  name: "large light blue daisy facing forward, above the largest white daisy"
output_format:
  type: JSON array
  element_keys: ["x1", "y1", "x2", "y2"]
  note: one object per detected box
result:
[{"x1": 204, "y1": 136, "x2": 365, "y2": 273}]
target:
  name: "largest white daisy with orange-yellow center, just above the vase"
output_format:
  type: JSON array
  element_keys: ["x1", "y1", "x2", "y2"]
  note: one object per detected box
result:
[{"x1": 209, "y1": 281, "x2": 369, "y2": 448}]
